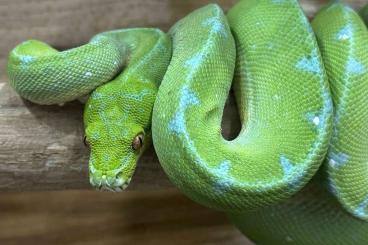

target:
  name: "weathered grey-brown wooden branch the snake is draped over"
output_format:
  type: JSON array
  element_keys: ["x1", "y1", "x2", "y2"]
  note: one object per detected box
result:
[{"x1": 0, "y1": 75, "x2": 238, "y2": 190}]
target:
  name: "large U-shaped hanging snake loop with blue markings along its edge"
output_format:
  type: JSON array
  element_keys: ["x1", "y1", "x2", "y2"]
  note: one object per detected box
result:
[{"x1": 152, "y1": 0, "x2": 332, "y2": 211}]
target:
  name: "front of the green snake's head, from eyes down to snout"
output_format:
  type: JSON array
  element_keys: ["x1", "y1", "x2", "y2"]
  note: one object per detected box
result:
[{"x1": 85, "y1": 123, "x2": 147, "y2": 192}]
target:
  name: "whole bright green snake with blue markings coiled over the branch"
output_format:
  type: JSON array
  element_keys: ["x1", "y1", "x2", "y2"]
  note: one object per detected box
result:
[{"x1": 8, "y1": 0, "x2": 368, "y2": 245}]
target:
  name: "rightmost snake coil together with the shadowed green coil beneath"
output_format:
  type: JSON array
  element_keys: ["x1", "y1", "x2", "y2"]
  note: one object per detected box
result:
[{"x1": 229, "y1": 3, "x2": 368, "y2": 245}]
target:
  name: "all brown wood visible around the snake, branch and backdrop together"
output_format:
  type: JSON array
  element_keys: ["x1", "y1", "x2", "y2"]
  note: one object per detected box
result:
[{"x1": 0, "y1": 0, "x2": 366, "y2": 245}]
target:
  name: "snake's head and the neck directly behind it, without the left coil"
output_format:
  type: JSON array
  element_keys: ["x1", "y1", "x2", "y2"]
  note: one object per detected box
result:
[{"x1": 84, "y1": 28, "x2": 171, "y2": 191}]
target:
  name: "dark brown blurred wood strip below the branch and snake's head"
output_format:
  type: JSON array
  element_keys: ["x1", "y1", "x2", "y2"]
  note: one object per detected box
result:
[{"x1": 0, "y1": 191, "x2": 252, "y2": 245}]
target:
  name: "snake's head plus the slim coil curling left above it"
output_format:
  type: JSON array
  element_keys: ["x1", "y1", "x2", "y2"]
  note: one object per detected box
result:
[{"x1": 8, "y1": 28, "x2": 171, "y2": 191}]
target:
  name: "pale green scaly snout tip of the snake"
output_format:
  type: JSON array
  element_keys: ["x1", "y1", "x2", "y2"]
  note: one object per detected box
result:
[{"x1": 90, "y1": 174, "x2": 130, "y2": 192}]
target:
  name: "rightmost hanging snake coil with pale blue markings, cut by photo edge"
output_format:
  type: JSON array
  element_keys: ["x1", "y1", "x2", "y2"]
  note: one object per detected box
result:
[{"x1": 312, "y1": 1, "x2": 368, "y2": 220}]
